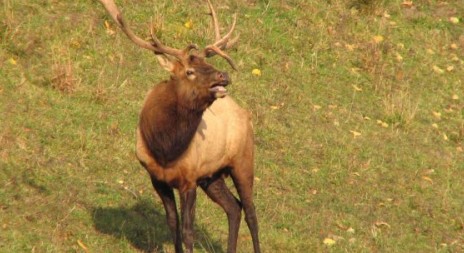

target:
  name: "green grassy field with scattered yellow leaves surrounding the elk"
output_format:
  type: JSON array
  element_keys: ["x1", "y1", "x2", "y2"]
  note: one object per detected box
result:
[{"x1": 0, "y1": 0, "x2": 464, "y2": 252}]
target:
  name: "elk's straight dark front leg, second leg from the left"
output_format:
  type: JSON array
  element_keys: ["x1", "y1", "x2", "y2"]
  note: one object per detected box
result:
[{"x1": 179, "y1": 188, "x2": 197, "y2": 253}]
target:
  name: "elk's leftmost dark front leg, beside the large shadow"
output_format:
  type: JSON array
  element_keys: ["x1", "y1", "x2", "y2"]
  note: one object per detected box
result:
[{"x1": 151, "y1": 177, "x2": 184, "y2": 253}]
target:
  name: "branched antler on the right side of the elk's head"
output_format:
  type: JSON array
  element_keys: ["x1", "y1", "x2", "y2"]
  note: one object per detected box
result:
[{"x1": 203, "y1": 0, "x2": 239, "y2": 70}]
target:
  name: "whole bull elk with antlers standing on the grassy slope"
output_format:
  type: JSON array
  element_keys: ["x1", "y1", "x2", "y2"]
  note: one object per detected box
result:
[{"x1": 100, "y1": 0, "x2": 260, "y2": 252}]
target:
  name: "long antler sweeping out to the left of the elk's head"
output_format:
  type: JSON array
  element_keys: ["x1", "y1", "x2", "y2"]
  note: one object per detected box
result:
[{"x1": 99, "y1": 0, "x2": 184, "y2": 59}]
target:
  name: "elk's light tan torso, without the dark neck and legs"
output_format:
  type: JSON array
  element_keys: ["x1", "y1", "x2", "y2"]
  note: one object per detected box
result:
[{"x1": 136, "y1": 96, "x2": 253, "y2": 191}]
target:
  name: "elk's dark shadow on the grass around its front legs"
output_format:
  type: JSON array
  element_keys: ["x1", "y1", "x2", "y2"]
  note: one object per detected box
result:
[{"x1": 92, "y1": 200, "x2": 224, "y2": 252}]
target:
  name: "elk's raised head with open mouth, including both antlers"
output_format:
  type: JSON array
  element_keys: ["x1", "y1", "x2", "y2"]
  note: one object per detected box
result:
[{"x1": 96, "y1": 0, "x2": 238, "y2": 100}]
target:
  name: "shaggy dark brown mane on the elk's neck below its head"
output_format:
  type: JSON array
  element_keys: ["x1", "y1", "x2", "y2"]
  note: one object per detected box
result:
[{"x1": 139, "y1": 80, "x2": 213, "y2": 167}]
